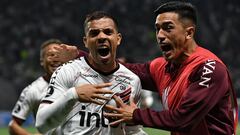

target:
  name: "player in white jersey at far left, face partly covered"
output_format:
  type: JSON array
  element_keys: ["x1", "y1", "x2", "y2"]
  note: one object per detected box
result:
[{"x1": 9, "y1": 39, "x2": 79, "y2": 135}]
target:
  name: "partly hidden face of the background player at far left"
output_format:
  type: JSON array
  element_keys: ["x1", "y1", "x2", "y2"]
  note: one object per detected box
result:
[{"x1": 41, "y1": 44, "x2": 62, "y2": 75}]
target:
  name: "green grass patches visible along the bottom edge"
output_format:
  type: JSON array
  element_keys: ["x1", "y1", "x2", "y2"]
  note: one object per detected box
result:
[{"x1": 0, "y1": 125, "x2": 240, "y2": 135}]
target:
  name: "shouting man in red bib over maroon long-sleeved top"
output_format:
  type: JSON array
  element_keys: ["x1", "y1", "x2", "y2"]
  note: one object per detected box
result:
[{"x1": 102, "y1": 1, "x2": 238, "y2": 135}]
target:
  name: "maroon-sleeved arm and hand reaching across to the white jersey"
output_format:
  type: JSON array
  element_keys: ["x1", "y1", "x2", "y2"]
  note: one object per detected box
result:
[{"x1": 105, "y1": 63, "x2": 232, "y2": 131}]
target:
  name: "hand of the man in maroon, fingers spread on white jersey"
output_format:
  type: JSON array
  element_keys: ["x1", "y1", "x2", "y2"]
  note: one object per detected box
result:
[{"x1": 104, "y1": 95, "x2": 137, "y2": 126}]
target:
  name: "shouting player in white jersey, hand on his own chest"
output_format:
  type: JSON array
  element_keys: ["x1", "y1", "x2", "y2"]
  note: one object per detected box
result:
[{"x1": 36, "y1": 11, "x2": 145, "y2": 135}]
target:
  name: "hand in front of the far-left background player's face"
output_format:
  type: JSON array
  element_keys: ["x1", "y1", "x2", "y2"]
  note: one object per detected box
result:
[{"x1": 52, "y1": 44, "x2": 78, "y2": 63}]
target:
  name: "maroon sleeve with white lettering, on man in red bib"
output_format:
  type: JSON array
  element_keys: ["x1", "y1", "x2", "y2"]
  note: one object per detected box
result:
[{"x1": 133, "y1": 62, "x2": 230, "y2": 131}]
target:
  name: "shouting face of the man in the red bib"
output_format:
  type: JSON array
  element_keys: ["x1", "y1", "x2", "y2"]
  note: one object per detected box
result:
[{"x1": 155, "y1": 12, "x2": 187, "y2": 62}]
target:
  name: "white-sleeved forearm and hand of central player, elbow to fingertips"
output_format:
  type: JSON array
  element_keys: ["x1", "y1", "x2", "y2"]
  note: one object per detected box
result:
[{"x1": 36, "y1": 83, "x2": 112, "y2": 133}]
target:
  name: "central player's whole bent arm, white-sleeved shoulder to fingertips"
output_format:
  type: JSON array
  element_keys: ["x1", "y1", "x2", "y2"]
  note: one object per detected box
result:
[{"x1": 36, "y1": 65, "x2": 112, "y2": 133}]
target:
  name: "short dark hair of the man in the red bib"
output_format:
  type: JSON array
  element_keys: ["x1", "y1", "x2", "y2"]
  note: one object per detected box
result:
[{"x1": 154, "y1": 1, "x2": 197, "y2": 25}]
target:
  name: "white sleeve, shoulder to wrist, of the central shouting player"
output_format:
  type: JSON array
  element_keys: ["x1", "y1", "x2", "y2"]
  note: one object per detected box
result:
[{"x1": 35, "y1": 62, "x2": 78, "y2": 133}]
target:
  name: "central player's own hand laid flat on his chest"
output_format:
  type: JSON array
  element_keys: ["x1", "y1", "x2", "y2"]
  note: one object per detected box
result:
[{"x1": 75, "y1": 83, "x2": 113, "y2": 105}]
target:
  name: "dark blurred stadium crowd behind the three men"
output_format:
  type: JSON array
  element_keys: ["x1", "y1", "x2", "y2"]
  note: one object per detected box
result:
[{"x1": 0, "y1": 0, "x2": 240, "y2": 134}]
